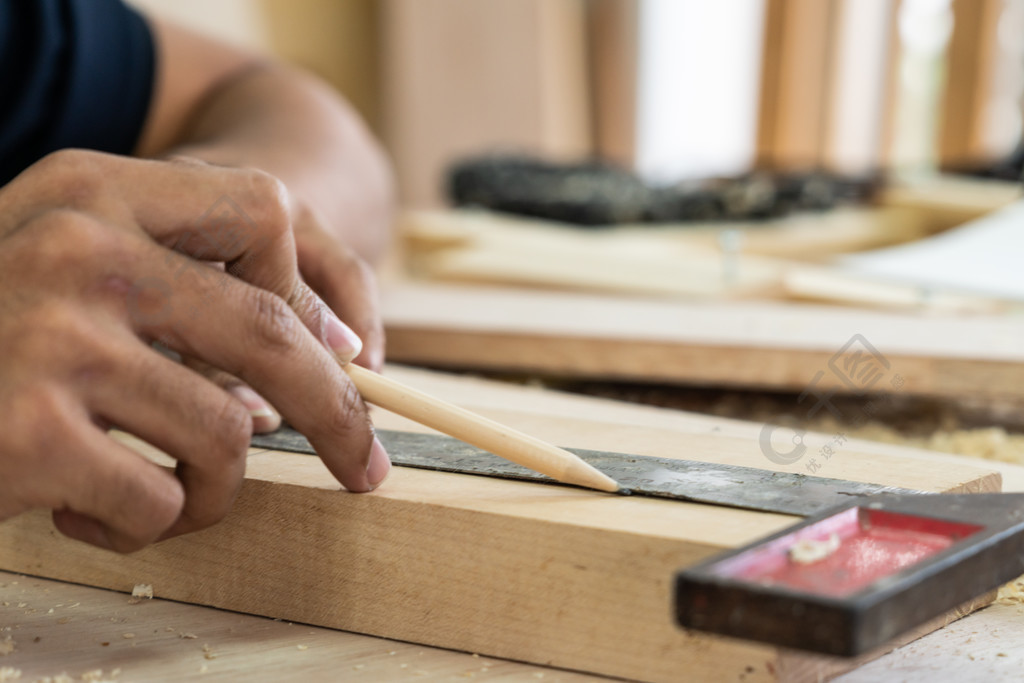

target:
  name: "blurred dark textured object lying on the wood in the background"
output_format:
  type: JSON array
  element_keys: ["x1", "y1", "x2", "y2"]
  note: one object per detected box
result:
[{"x1": 447, "y1": 155, "x2": 879, "y2": 225}]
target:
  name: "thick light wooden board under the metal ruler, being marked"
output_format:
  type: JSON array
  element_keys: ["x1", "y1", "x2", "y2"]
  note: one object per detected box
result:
[{"x1": 0, "y1": 369, "x2": 999, "y2": 681}]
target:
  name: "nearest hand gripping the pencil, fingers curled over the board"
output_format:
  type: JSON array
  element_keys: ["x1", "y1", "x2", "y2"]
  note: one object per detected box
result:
[{"x1": 0, "y1": 151, "x2": 390, "y2": 552}]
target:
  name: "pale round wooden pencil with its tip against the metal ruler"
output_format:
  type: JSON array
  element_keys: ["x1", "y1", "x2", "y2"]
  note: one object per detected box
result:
[{"x1": 342, "y1": 362, "x2": 622, "y2": 492}]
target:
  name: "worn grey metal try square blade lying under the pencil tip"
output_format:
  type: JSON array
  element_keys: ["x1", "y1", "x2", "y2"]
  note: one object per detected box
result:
[{"x1": 252, "y1": 427, "x2": 924, "y2": 516}]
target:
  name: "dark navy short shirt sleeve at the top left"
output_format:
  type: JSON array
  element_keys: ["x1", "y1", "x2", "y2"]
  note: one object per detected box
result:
[{"x1": 0, "y1": 0, "x2": 156, "y2": 184}]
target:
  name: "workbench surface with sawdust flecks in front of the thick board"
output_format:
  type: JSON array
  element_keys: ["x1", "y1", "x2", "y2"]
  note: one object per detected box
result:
[{"x1": 6, "y1": 572, "x2": 1024, "y2": 683}]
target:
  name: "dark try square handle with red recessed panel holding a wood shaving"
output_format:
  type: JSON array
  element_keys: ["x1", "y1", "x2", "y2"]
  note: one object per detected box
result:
[{"x1": 675, "y1": 494, "x2": 1024, "y2": 656}]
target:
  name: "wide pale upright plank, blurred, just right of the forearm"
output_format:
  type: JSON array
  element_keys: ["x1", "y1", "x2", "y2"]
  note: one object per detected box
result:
[{"x1": 381, "y1": 0, "x2": 592, "y2": 207}]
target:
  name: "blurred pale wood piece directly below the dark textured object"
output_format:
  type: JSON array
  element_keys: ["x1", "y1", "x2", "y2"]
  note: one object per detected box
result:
[{"x1": 401, "y1": 211, "x2": 786, "y2": 297}]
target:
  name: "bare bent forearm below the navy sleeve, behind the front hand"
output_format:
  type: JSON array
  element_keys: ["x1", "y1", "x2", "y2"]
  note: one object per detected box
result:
[{"x1": 167, "y1": 65, "x2": 393, "y2": 260}]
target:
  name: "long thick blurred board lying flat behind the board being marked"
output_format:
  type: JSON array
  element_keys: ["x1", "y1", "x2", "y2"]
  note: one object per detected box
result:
[{"x1": 382, "y1": 282, "x2": 1024, "y2": 401}]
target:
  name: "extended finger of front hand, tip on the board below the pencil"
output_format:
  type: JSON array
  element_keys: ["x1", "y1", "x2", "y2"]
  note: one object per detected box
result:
[{"x1": 122, "y1": 237, "x2": 387, "y2": 492}]
